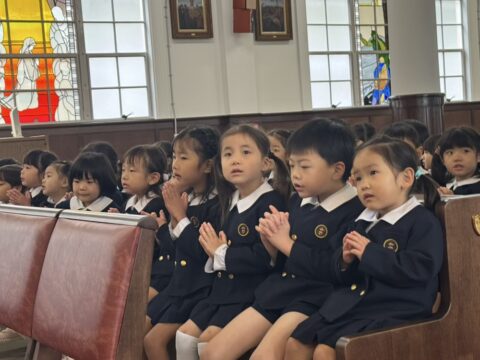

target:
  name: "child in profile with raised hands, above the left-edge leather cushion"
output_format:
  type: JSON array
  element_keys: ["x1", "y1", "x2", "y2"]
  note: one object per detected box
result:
[{"x1": 8, "y1": 150, "x2": 57, "y2": 207}]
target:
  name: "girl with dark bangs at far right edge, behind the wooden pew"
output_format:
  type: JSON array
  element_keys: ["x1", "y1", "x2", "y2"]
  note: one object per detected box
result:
[{"x1": 439, "y1": 127, "x2": 480, "y2": 195}]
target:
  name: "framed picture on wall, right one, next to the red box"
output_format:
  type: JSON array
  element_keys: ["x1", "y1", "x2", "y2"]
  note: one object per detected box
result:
[{"x1": 255, "y1": 0, "x2": 293, "y2": 41}]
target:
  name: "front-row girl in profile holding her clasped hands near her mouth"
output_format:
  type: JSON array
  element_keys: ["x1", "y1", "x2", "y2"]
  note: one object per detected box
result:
[{"x1": 145, "y1": 126, "x2": 219, "y2": 359}]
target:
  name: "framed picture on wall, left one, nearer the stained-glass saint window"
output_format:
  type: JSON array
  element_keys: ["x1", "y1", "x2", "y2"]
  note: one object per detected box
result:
[{"x1": 170, "y1": 0, "x2": 213, "y2": 39}]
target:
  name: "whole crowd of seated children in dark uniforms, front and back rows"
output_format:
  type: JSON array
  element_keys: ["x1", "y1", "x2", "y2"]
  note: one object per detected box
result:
[{"x1": 0, "y1": 119, "x2": 480, "y2": 360}]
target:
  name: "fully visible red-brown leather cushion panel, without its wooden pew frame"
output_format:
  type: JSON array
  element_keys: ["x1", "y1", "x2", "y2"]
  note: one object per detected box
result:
[{"x1": 33, "y1": 218, "x2": 141, "y2": 360}]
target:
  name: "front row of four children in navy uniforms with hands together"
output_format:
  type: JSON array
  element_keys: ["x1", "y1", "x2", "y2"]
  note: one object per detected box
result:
[{"x1": 0, "y1": 120, "x2": 476, "y2": 359}]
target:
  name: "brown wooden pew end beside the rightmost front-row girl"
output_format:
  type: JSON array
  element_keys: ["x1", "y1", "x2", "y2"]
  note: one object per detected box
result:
[{"x1": 336, "y1": 195, "x2": 480, "y2": 360}]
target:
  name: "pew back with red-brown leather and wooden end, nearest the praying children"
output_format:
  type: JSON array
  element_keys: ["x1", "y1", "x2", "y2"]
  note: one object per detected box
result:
[{"x1": 32, "y1": 211, "x2": 157, "y2": 360}]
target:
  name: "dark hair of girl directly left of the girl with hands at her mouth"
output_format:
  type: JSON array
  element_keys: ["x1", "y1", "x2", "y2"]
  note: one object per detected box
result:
[{"x1": 123, "y1": 145, "x2": 167, "y2": 195}]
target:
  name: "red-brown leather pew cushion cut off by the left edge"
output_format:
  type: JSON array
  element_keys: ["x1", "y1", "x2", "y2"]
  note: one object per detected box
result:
[{"x1": 0, "y1": 209, "x2": 56, "y2": 336}]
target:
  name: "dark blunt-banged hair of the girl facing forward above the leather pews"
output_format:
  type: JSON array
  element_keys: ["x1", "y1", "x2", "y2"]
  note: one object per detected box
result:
[{"x1": 68, "y1": 152, "x2": 117, "y2": 197}]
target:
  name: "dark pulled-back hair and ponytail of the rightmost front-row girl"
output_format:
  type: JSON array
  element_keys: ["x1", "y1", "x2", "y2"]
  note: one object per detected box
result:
[{"x1": 357, "y1": 136, "x2": 440, "y2": 211}]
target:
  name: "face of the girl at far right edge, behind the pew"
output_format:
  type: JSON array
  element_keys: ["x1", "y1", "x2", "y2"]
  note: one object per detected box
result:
[{"x1": 443, "y1": 147, "x2": 478, "y2": 180}]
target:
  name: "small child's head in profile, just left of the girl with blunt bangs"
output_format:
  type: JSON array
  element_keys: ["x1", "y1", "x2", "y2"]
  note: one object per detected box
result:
[{"x1": 42, "y1": 160, "x2": 72, "y2": 207}]
